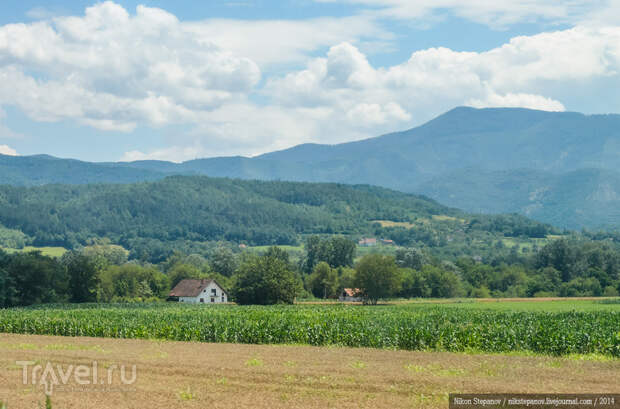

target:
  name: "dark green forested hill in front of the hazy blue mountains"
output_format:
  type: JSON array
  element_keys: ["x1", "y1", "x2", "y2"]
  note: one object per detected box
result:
[{"x1": 0, "y1": 176, "x2": 554, "y2": 260}]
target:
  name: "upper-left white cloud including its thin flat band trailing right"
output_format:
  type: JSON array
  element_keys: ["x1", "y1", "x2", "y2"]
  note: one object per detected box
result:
[{"x1": 0, "y1": 1, "x2": 391, "y2": 143}]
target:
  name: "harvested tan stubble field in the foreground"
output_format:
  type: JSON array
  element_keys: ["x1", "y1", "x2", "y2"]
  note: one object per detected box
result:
[{"x1": 0, "y1": 334, "x2": 620, "y2": 409}]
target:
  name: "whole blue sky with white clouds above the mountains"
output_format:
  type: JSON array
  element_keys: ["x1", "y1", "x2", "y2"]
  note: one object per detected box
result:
[{"x1": 0, "y1": 0, "x2": 620, "y2": 162}]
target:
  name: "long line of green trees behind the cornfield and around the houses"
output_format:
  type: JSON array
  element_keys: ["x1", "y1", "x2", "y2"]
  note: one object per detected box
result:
[{"x1": 0, "y1": 236, "x2": 620, "y2": 307}]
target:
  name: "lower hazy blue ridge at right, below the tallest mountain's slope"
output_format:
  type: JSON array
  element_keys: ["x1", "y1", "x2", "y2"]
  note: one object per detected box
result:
[{"x1": 419, "y1": 168, "x2": 620, "y2": 230}]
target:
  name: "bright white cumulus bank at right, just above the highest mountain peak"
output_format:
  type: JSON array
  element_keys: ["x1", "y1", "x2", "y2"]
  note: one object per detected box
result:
[{"x1": 266, "y1": 27, "x2": 620, "y2": 139}]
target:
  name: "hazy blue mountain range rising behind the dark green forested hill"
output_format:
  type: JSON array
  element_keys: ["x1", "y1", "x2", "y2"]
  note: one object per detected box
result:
[{"x1": 0, "y1": 107, "x2": 620, "y2": 229}]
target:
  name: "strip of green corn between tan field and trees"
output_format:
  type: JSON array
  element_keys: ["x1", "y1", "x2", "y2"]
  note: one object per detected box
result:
[{"x1": 0, "y1": 304, "x2": 620, "y2": 357}]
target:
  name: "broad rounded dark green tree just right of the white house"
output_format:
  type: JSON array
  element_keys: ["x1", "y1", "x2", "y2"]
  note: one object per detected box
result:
[{"x1": 232, "y1": 250, "x2": 302, "y2": 305}]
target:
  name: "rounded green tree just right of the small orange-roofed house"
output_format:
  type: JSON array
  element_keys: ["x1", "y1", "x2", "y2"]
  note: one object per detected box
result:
[{"x1": 355, "y1": 254, "x2": 400, "y2": 305}]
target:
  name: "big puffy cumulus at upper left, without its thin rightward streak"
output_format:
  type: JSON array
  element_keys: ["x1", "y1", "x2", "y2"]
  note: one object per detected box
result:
[{"x1": 0, "y1": 1, "x2": 261, "y2": 131}]
